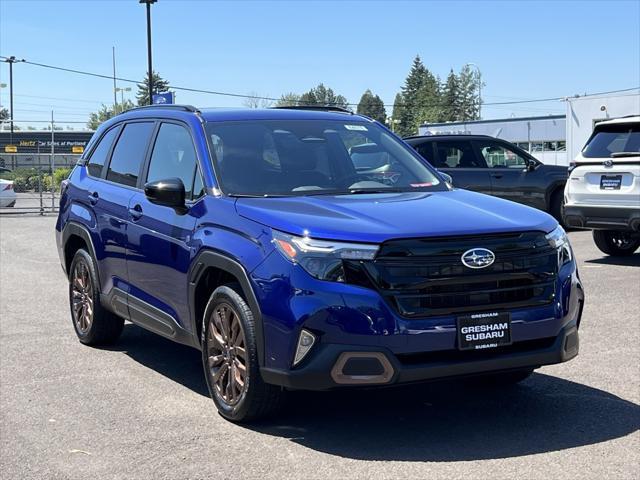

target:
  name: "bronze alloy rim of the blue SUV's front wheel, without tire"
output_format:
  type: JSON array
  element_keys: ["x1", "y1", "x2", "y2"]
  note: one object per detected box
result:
[{"x1": 207, "y1": 303, "x2": 247, "y2": 406}]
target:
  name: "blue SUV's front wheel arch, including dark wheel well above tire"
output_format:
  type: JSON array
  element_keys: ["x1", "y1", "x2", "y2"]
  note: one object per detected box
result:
[{"x1": 188, "y1": 250, "x2": 264, "y2": 366}]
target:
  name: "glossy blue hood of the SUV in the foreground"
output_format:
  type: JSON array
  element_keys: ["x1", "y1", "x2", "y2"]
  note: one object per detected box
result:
[{"x1": 236, "y1": 190, "x2": 557, "y2": 243}]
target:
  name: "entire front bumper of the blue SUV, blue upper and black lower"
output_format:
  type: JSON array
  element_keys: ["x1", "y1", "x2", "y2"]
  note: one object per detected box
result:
[{"x1": 251, "y1": 242, "x2": 584, "y2": 390}]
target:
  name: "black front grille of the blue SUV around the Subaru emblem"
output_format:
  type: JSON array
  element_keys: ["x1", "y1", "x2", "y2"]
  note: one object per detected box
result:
[{"x1": 362, "y1": 232, "x2": 557, "y2": 318}]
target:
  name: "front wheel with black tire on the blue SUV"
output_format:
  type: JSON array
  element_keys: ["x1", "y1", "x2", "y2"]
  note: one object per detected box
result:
[{"x1": 202, "y1": 285, "x2": 284, "y2": 422}]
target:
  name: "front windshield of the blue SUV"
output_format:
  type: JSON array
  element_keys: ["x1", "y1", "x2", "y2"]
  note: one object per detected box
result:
[{"x1": 206, "y1": 119, "x2": 447, "y2": 196}]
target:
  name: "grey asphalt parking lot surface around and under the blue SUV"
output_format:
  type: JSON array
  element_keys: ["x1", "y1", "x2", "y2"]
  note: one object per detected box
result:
[{"x1": 0, "y1": 215, "x2": 640, "y2": 479}]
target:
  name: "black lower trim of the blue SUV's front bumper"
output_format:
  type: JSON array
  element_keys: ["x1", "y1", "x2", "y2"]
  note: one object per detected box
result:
[{"x1": 261, "y1": 318, "x2": 581, "y2": 390}]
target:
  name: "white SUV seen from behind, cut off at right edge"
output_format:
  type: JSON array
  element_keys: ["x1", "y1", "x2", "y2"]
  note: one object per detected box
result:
[{"x1": 563, "y1": 115, "x2": 640, "y2": 256}]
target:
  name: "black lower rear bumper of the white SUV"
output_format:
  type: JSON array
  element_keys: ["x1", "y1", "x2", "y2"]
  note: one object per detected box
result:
[{"x1": 562, "y1": 205, "x2": 640, "y2": 232}]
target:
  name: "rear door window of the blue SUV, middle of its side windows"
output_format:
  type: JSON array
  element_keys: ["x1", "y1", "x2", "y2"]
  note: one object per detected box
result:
[{"x1": 107, "y1": 122, "x2": 154, "y2": 187}]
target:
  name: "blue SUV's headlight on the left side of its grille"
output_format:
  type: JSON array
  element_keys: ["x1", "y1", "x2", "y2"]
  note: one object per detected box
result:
[{"x1": 273, "y1": 230, "x2": 378, "y2": 282}]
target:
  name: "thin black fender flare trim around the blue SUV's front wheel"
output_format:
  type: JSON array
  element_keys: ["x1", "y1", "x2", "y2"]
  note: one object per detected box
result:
[{"x1": 188, "y1": 250, "x2": 264, "y2": 366}]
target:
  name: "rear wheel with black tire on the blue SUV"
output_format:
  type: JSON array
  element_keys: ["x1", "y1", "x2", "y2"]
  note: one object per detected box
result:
[{"x1": 69, "y1": 249, "x2": 124, "y2": 345}]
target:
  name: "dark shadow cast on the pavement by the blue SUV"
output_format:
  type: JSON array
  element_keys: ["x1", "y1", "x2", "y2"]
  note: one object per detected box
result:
[{"x1": 110, "y1": 324, "x2": 640, "y2": 462}]
